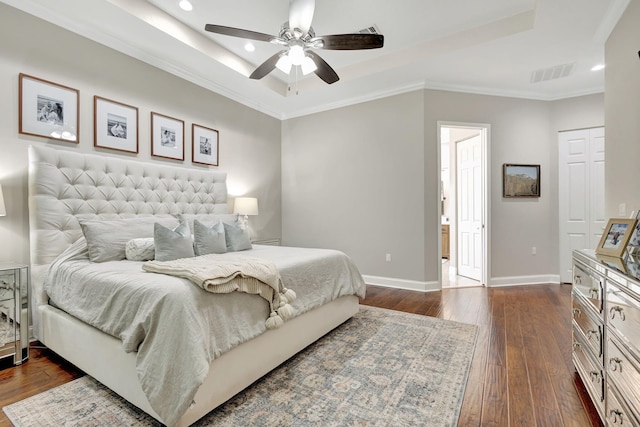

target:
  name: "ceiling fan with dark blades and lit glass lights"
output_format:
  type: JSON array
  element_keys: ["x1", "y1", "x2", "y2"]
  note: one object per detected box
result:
[{"x1": 204, "y1": 0, "x2": 384, "y2": 84}]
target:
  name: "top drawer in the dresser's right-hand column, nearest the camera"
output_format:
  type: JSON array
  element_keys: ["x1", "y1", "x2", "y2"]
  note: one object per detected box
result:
[{"x1": 606, "y1": 282, "x2": 640, "y2": 352}]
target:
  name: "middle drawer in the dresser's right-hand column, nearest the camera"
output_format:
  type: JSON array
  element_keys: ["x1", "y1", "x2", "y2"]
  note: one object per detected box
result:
[{"x1": 605, "y1": 336, "x2": 640, "y2": 413}]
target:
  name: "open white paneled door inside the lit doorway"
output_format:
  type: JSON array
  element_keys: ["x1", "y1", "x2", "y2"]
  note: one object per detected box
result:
[{"x1": 456, "y1": 135, "x2": 483, "y2": 281}]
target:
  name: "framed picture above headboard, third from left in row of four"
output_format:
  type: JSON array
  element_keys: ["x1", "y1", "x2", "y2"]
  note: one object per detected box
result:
[{"x1": 151, "y1": 112, "x2": 184, "y2": 160}]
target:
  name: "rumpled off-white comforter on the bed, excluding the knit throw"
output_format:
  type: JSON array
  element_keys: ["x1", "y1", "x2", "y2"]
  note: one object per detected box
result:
[{"x1": 45, "y1": 238, "x2": 365, "y2": 425}]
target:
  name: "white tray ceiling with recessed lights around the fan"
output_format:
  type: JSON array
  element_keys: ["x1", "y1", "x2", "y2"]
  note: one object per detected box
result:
[{"x1": 0, "y1": 0, "x2": 630, "y2": 119}]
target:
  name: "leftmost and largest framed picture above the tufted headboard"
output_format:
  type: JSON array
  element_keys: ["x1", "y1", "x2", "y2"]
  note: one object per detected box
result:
[{"x1": 18, "y1": 73, "x2": 80, "y2": 143}]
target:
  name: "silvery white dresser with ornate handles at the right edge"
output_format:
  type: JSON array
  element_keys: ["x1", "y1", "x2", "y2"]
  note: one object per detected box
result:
[{"x1": 572, "y1": 250, "x2": 640, "y2": 426}]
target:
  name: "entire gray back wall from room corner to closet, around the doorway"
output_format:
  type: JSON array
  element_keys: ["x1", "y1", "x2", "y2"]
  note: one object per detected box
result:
[{"x1": 282, "y1": 90, "x2": 604, "y2": 289}]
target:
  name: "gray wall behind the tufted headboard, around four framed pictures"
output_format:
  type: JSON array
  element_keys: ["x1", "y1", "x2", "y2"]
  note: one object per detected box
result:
[{"x1": 0, "y1": 4, "x2": 282, "y2": 262}]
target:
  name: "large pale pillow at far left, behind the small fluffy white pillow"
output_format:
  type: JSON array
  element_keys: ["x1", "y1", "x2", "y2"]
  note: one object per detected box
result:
[{"x1": 80, "y1": 216, "x2": 179, "y2": 262}]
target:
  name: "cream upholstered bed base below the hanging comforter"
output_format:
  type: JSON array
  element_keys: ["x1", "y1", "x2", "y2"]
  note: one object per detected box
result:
[{"x1": 38, "y1": 295, "x2": 358, "y2": 426}]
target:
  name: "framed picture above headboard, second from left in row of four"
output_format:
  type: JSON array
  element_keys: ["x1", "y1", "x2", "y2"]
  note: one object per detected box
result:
[{"x1": 93, "y1": 96, "x2": 138, "y2": 153}]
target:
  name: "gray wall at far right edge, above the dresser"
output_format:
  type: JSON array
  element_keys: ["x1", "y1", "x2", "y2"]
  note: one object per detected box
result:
[{"x1": 605, "y1": 1, "x2": 640, "y2": 218}]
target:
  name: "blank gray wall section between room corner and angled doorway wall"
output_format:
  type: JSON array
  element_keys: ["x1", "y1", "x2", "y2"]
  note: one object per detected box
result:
[{"x1": 282, "y1": 92, "x2": 427, "y2": 280}]
